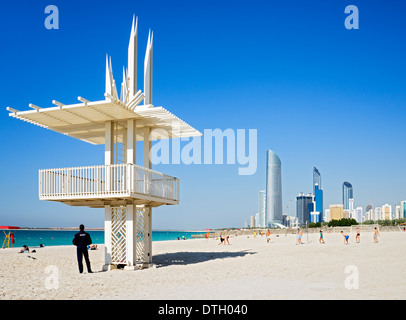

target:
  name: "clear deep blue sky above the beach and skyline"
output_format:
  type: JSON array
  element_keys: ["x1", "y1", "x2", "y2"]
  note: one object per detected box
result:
[{"x1": 0, "y1": 0, "x2": 406, "y2": 229}]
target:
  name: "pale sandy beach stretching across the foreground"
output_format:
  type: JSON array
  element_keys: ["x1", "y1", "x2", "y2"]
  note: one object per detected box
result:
[{"x1": 0, "y1": 232, "x2": 406, "y2": 300}]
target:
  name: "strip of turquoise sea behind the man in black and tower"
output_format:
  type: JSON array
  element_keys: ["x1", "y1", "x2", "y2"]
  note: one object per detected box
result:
[{"x1": 0, "y1": 230, "x2": 204, "y2": 248}]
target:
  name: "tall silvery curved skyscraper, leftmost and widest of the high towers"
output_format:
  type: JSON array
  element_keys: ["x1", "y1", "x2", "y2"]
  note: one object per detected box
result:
[{"x1": 265, "y1": 150, "x2": 282, "y2": 226}]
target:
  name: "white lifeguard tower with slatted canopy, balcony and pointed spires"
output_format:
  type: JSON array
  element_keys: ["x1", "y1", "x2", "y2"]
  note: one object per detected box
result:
[{"x1": 7, "y1": 17, "x2": 202, "y2": 270}]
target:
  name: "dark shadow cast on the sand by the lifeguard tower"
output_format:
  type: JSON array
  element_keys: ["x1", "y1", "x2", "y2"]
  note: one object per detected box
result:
[{"x1": 153, "y1": 250, "x2": 256, "y2": 267}]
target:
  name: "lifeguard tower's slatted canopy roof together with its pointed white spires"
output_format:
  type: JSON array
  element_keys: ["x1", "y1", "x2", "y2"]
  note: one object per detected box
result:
[{"x1": 7, "y1": 16, "x2": 202, "y2": 144}]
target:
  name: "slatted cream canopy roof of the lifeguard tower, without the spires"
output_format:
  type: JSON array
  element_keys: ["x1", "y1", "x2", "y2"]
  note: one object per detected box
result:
[{"x1": 8, "y1": 97, "x2": 202, "y2": 145}]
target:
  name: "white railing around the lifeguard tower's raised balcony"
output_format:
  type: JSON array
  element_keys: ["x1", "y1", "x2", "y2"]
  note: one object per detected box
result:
[{"x1": 39, "y1": 164, "x2": 179, "y2": 201}]
